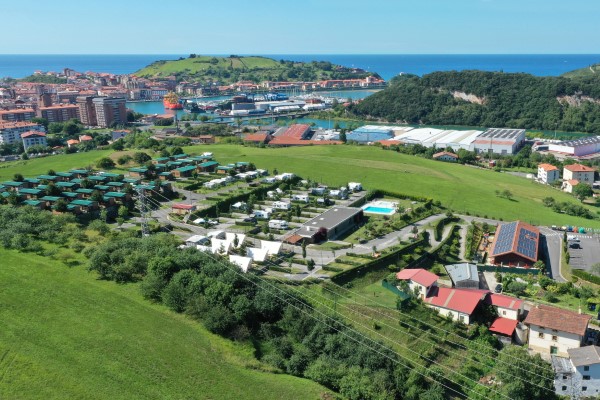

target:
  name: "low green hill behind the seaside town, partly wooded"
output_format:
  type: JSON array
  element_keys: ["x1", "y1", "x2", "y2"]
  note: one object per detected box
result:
[{"x1": 134, "y1": 55, "x2": 376, "y2": 84}]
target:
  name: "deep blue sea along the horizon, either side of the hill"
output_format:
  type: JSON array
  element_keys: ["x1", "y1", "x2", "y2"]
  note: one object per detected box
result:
[{"x1": 0, "y1": 54, "x2": 600, "y2": 80}]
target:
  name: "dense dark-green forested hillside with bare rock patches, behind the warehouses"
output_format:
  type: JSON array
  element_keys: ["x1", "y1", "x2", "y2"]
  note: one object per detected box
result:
[{"x1": 351, "y1": 71, "x2": 600, "y2": 133}]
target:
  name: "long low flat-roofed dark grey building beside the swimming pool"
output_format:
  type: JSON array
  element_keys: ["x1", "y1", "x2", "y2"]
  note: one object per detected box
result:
[{"x1": 295, "y1": 207, "x2": 363, "y2": 243}]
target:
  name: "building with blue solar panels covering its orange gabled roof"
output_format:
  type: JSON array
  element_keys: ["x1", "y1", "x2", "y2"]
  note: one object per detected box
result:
[{"x1": 490, "y1": 221, "x2": 540, "y2": 268}]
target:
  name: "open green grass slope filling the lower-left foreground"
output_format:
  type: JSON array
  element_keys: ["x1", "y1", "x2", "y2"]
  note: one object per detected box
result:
[{"x1": 0, "y1": 250, "x2": 326, "y2": 400}]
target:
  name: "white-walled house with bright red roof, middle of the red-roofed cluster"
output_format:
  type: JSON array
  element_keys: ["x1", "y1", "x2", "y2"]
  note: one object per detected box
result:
[{"x1": 423, "y1": 286, "x2": 489, "y2": 325}]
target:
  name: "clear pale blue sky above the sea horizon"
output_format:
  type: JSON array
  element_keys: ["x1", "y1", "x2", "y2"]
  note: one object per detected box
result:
[{"x1": 0, "y1": 0, "x2": 600, "y2": 54}]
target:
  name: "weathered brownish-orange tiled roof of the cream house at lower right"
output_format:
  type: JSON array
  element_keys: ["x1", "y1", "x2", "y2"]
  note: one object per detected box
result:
[{"x1": 525, "y1": 304, "x2": 592, "y2": 336}]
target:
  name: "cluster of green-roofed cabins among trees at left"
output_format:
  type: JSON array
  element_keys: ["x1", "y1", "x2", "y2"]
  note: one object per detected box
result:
[{"x1": 0, "y1": 169, "x2": 171, "y2": 214}]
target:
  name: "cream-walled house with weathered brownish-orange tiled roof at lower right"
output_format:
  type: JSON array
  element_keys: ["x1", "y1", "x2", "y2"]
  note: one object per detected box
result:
[{"x1": 524, "y1": 304, "x2": 592, "y2": 357}]
